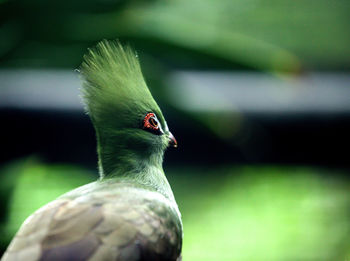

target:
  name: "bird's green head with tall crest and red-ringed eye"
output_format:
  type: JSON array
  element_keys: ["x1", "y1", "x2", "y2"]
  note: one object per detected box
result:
[{"x1": 80, "y1": 40, "x2": 177, "y2": 176}]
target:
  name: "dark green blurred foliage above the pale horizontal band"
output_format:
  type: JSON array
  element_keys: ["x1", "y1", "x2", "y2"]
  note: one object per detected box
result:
[{"x1": 0, "y1": 0, "x2": 350, "y2": 72}]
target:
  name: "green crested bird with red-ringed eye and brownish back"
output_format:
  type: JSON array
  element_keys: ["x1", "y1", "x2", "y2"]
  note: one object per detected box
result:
[{"x1": 1, "y1": 40, "x2": 183, "y2": 261}]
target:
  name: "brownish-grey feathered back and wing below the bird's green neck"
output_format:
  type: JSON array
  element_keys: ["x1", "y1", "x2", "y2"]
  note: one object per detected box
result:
[{"x1": 2, "y1": 188, "x2": 181, "y2": 261}]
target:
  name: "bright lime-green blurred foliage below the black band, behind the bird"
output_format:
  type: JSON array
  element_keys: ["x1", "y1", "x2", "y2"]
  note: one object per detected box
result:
[{"x1": 1, "y1": 159, "x2": 350, "y2": 261}]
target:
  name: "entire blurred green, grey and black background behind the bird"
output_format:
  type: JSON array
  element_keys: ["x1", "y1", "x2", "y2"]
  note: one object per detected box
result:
[{"x1": 0, "y1": 0, "x2": 350, "y2": 261}]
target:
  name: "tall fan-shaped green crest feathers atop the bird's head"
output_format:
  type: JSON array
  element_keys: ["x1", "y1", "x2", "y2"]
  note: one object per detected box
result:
[{"x1": 81, "y1": 40, "x2": 164, "y2": 129}]
